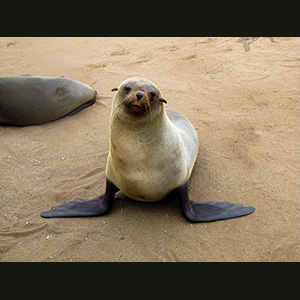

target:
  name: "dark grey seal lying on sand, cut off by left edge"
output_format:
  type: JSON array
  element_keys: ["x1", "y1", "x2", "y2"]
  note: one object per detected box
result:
[{"x1": 0, "y1": 76, "x2": 96, "y2": 125}]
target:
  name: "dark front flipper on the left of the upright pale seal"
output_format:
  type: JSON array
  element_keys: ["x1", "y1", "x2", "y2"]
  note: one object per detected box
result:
[{"x1": 41, "y1": 180, "x2": 118, "y2": 218}]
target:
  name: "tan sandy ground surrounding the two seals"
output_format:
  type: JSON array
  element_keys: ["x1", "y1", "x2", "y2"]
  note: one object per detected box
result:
[{"x1": 0, "y1": 37, "x2": 300, "y2": 262}]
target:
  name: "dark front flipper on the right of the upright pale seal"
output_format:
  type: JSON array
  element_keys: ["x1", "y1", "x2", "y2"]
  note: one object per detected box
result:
[{"x1": 175, "y1": 184, "x2": 255, "y2": 222}]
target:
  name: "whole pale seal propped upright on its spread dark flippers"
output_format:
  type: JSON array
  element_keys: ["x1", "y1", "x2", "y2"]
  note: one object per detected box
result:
[{"x1": 41, "y1": 78, "x2": 255, "y2": 222}]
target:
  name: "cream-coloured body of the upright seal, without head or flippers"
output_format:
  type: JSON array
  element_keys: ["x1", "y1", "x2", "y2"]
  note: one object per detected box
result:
[{"x1": 106, "y1": 106, "x2": 198, "y2": 201}]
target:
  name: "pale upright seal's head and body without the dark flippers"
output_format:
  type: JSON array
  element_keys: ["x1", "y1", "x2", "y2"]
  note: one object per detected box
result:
[{"x1": 106, "y1": 78, "x2": 198, "y2": 201}]
